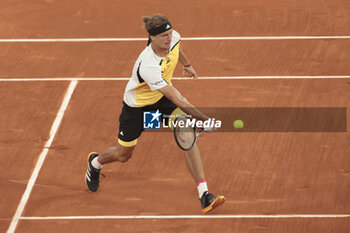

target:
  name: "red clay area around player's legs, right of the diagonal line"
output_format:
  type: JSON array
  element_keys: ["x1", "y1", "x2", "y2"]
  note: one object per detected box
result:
[{"x1": 24, "y1": 80, "x2": 350, "y2": 216}]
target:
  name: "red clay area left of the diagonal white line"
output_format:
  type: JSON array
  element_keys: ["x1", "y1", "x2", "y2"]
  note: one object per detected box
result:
[{"x1": 0, "y1": 82, "x2": 67, "y2": 219}]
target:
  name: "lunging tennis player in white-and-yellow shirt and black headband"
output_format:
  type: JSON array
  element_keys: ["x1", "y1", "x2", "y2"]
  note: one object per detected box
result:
[{"x1": 86, "y1": 14, "x2": 225, "y2": 213}]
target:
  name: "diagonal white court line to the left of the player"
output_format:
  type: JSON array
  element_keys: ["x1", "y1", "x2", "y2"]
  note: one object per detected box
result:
[{"x1": 7, "y1": 81, "x2": 78, "y2": 233}]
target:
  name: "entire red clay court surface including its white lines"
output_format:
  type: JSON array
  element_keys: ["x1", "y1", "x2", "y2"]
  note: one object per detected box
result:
[{"x1": 0, "y1": 0, "x2": 350, "y2": 233}]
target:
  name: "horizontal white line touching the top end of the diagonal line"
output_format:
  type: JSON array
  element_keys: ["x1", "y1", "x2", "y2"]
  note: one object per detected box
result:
[{"x1": 0, "y1": 75, "x2": 350, "y2": 82}]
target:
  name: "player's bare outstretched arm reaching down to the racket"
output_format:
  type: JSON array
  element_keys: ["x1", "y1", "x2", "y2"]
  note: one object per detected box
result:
[{"x1": 158, "y1": 84, "x2": 209, "y2": 121}]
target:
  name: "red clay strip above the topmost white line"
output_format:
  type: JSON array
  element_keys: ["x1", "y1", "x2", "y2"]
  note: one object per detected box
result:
[{"x1": 0, "y1": 0, "x2": 350, "y2": 38}]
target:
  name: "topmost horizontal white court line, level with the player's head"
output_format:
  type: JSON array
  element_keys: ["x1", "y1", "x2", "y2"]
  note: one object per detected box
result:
[{"x1": 0, "y1": 36, "x2": 350, "y2": 43}]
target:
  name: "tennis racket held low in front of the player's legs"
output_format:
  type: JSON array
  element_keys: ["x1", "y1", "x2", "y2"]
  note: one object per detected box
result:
[{"x1": 173, "y1": 116, "x2": 204, "y2": 151}]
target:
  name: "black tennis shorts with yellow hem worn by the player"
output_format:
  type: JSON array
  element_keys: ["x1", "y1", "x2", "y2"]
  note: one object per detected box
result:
[{"x1": 118, "y1": 96, "x2": 177, "y2": 142}]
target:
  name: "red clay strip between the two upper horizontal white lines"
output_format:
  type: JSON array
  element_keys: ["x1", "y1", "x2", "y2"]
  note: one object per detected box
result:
[{"x1": 0, "y1": 40, "x2": 350, "y2": 78}]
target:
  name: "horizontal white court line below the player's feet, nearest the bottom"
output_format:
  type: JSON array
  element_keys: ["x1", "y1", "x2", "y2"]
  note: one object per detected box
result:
[{"x1": 21, "y1": 214, "x2": 350, "y2": 220}]
